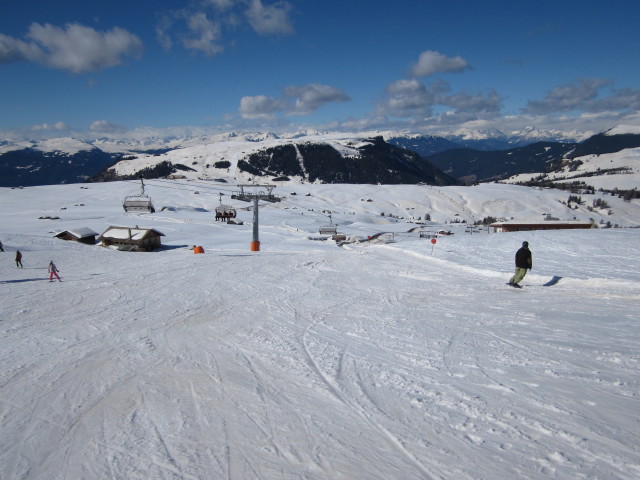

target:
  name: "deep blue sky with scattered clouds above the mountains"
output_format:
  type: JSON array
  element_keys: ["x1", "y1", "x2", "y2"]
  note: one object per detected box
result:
[{"x1": 0, "y1": 0, "x2": 640, "y2": 136}]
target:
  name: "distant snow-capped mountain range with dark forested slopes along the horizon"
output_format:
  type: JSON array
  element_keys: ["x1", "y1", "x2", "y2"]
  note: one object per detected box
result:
[{"x1": 0, "y1": 125, "x2": 640, "y2": 188}]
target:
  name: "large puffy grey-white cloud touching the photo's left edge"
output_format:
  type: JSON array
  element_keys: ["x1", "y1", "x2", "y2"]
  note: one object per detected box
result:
[{"x1": 0, "y1": 23, "x2": 143, "y2": 73}]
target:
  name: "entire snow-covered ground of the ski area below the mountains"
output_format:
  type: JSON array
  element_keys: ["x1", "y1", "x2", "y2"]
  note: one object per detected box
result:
[{"x1": 0, "y1": 182, "x2": 640, "y2": 480}]
